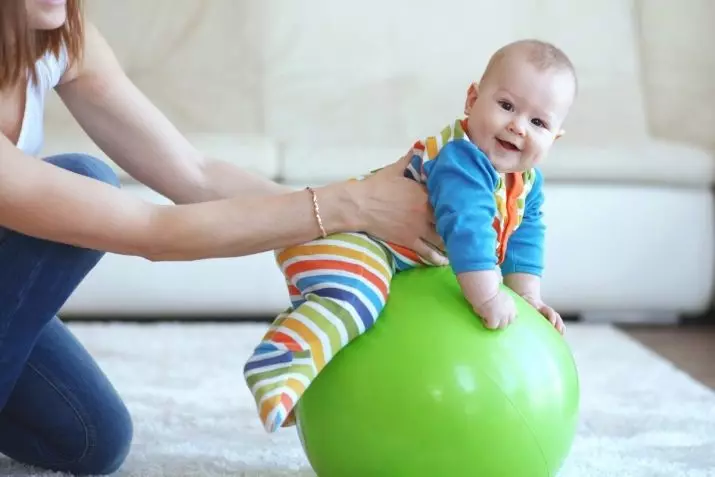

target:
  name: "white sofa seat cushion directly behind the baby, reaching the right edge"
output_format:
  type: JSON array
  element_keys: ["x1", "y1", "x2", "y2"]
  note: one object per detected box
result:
[{"x1": 281, "y1": 140, "x2": 715, "y2": 187}]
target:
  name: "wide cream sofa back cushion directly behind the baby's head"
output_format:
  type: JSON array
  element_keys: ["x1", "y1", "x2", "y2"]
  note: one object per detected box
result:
[{"x1": 260, "y1": 0, "x2": 647, "y2": 148}]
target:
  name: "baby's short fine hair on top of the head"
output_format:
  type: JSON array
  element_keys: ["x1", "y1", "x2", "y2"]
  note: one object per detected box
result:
[{"x1": 482, "y1": 38, "x2": 578, "y2": 92}]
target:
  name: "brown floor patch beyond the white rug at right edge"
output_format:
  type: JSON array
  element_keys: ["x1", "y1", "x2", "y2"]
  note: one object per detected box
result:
[{"x1": 621, "y1": 323, "x2": 715, "y2": 390}]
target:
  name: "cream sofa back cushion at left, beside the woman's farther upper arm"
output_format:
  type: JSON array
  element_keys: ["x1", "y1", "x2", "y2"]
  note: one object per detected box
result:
[{"x1": 77, "y1": 0, "x2": 263, "y2": 139}]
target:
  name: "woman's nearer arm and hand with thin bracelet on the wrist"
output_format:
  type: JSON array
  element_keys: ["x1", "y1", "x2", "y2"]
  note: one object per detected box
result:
[{"x1": 0, "y1": 134, "x2": 440, "y2": 262}]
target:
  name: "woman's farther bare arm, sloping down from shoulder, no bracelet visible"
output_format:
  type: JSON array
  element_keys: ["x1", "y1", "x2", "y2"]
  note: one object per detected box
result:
[{"x1": 56, "y1": 22, "x2": 288, "y2": 203}]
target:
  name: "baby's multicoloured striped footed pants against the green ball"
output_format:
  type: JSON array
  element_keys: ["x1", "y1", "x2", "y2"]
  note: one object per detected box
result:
[{"x1": 244, "y1": 233, "x2": 427, "y2": 432}]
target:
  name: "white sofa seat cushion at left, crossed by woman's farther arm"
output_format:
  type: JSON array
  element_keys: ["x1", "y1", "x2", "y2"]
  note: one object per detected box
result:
[{"x1": 42, "y1": 130, "x2": 280, "y2": 183}]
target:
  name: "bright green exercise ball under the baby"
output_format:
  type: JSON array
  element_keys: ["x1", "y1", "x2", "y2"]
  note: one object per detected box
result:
[{"x1": 295, "y1": 267, "x2": 580, "y2": 477}]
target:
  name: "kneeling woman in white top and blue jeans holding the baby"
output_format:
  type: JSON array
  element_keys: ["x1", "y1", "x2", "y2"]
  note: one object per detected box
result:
[{"x1": 0, "y1": 0, "x2": 444, "y2": 474}]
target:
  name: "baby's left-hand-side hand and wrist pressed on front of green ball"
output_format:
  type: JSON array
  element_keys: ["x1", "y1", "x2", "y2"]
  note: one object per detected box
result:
[{"x1": 457, "y1": 271, "x2": 516, "y2": 329}]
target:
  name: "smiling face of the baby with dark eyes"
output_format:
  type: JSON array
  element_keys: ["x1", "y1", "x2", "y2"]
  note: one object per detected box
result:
[{"x1": 466, "y1": 57, "x2": 575, "y2": 172}]
